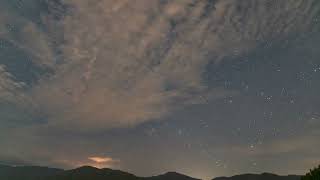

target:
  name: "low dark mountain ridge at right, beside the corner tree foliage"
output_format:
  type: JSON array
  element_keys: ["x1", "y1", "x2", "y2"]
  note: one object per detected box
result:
[{"x1": 213, "y1": 173, "x2": 301, "y2": 180}]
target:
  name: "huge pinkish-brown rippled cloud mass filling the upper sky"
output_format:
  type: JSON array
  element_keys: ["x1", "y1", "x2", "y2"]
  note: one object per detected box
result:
[{"x1": 0, "y1": 0, "x2": 319, "y2": 130}]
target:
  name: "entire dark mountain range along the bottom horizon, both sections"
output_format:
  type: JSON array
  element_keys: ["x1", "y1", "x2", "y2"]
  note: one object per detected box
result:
[{"x1": 0, "y1": 165, "x2": 300, "y2": 180}]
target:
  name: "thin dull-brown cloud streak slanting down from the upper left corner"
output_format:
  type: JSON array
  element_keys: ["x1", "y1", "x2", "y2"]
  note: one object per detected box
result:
[{"x1": 0, "y1": 1, "x2": 55, "y2": 67}]
